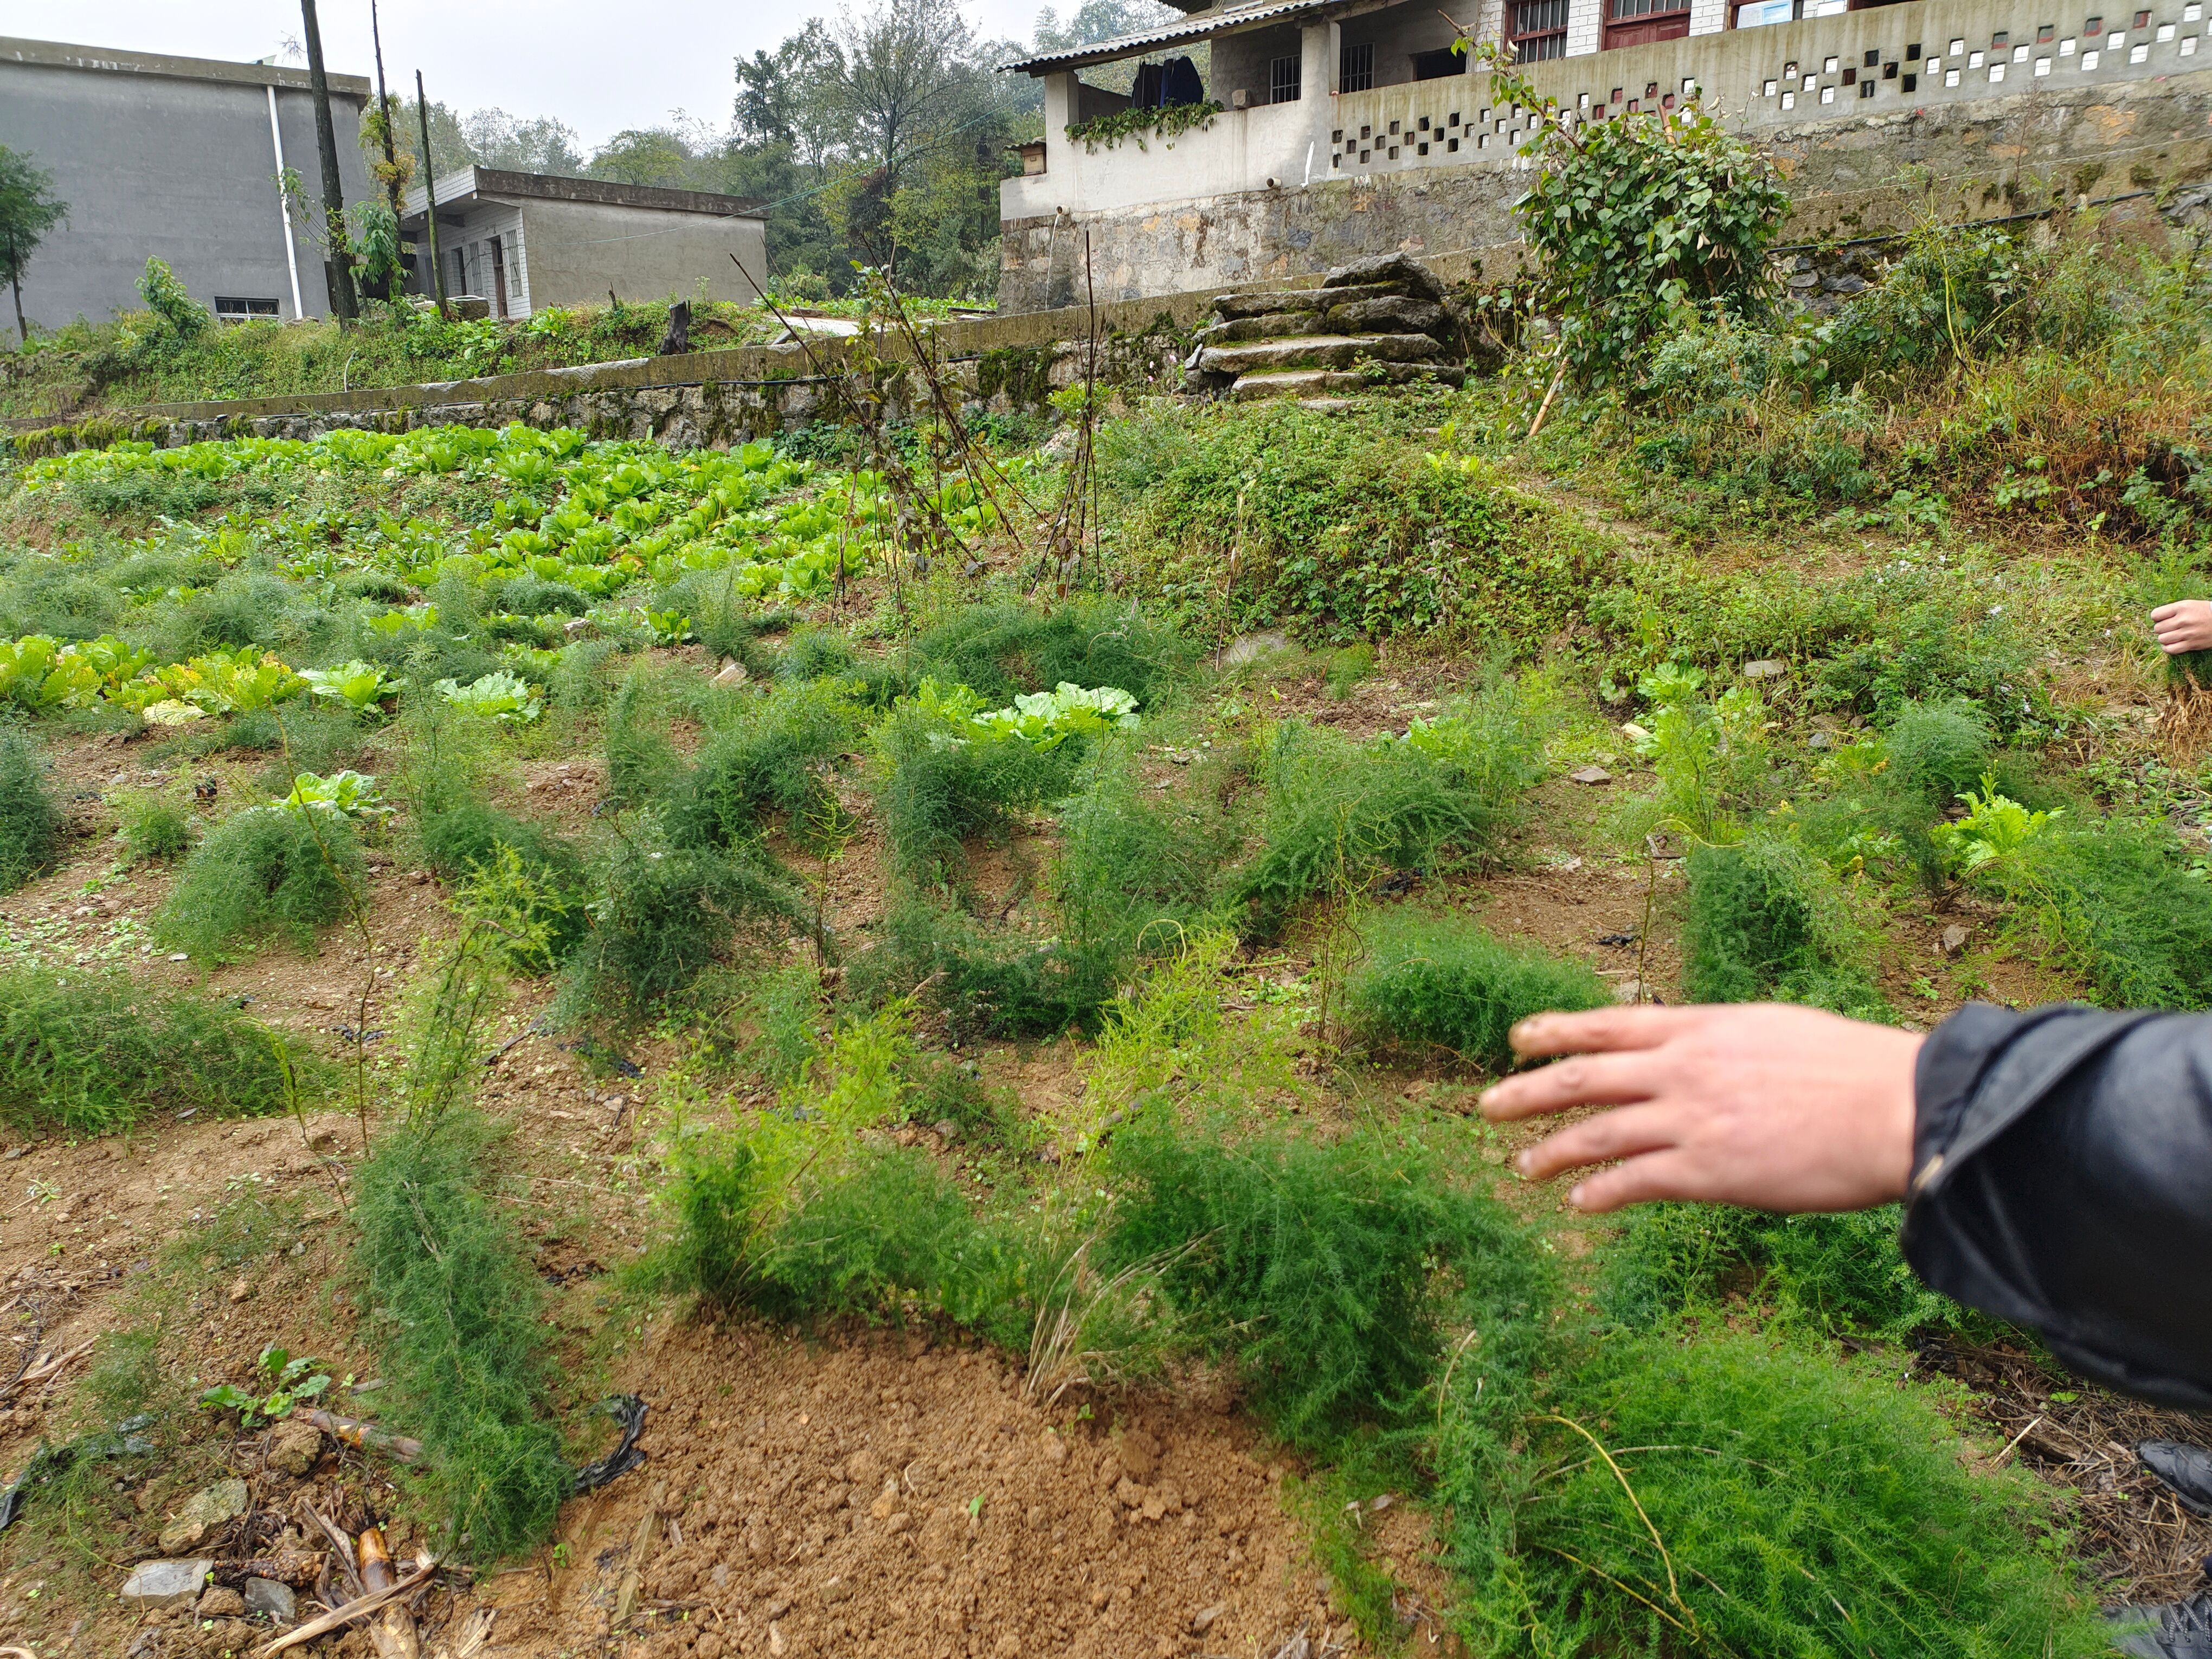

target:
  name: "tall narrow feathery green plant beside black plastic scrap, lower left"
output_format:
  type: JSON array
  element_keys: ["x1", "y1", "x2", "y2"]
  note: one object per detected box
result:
[{"x1": 354, "y1": 1115, "x2": 569, "y2": 1559}]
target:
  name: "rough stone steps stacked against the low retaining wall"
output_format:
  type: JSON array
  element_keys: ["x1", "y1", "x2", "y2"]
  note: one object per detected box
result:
[{"x1": 1184, "y1": 254, "x2": 1467, "y2": 403}]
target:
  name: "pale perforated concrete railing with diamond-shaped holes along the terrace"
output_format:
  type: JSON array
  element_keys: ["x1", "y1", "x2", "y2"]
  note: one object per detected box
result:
[{"x1": 1314, "y1": 0, "x2": 2212, "y2": 177}]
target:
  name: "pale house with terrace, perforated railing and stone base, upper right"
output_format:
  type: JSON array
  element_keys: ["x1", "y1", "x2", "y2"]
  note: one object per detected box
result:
[{"x1": 998, "y1": 0, "x2": 2212, "y2": 312}]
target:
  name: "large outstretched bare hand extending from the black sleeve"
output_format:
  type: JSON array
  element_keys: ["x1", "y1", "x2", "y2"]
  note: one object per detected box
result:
[{"x1": 1482, "y1": 1002, "x2": 1922, "y2": 1212}]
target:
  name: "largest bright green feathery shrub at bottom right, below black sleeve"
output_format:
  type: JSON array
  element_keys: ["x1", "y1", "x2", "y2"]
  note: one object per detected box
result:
[{"x1": 1442, "y1": 1329, "x2": 2110, "y2": 1659}]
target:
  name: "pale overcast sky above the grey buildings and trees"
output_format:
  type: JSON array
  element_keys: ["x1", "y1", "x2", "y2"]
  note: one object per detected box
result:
[{"x1": 0, "y1": 0, "x2": 1039, "y2": 148}]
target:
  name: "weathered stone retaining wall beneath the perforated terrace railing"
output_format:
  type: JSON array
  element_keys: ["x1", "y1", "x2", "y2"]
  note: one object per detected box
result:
[{"x1": 998, "y1": 62, "x2": 2212, "y2": 312}]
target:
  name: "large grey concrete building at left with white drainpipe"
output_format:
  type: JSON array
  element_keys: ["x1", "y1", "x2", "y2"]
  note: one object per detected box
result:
[{"x1": 0, "y1": 37, "x2": 369, "y2": 327}]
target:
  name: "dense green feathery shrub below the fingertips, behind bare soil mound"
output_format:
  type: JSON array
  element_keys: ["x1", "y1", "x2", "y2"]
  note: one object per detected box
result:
[{"x1": 1099, "y1": 1108, "x2": 1553, "y2": 1444}]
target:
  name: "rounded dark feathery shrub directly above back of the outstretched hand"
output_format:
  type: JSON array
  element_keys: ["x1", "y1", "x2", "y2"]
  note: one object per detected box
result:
[{"x1": 1683, "y1": 838, "x2": 1891, "y2": 1020}]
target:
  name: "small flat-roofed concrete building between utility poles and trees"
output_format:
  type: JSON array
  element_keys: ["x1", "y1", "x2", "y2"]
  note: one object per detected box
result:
[{"x1": 400, "y1": 166, "x2": 768, "y2": 316}]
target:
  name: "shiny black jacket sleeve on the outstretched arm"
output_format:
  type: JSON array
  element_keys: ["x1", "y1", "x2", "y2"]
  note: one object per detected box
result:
[{"x1": 1905, "y1": 1004, "x2": 2212, "y2": 1411}]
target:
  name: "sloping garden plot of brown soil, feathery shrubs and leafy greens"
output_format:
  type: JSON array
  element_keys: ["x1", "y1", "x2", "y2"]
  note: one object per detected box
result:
[{"x1": 0, "y1": 224, "x2": 2212, "y2": 1659}]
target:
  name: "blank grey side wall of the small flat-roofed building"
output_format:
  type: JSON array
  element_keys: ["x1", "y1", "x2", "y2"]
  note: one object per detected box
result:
[{"x1": 522, "y1": 201, "x2": 768, "y2": 310}]
